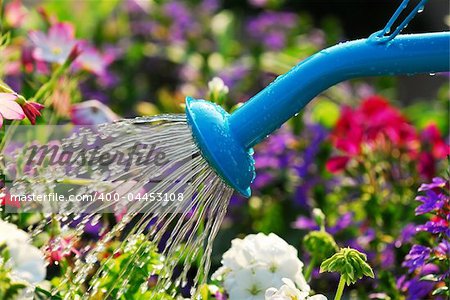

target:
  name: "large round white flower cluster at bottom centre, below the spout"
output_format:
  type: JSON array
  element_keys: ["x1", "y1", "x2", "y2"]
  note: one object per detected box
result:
[{"x1": 213, "y1": 233, "x2": 310, "y2": 300}]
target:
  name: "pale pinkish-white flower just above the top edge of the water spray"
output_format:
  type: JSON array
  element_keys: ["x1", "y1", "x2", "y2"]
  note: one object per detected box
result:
[{"x1": 70, "y1": 100, "x2": 119, "y2": 125}]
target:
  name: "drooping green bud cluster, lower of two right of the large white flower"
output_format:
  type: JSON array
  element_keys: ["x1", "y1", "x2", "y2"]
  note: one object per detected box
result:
[{"x1": 320, "y1": 248, "x2": 374, "y2": 285}]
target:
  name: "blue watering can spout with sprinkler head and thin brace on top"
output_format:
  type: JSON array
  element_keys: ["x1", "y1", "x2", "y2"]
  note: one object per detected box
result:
[{"x1": 186, "y1": 0, "x2": 450, "y2": 197}]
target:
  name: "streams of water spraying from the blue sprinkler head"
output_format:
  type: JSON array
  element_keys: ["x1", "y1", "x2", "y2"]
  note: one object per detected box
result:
[{"x1": 3, "y1": 115, "x2": 233, "y2": 299}]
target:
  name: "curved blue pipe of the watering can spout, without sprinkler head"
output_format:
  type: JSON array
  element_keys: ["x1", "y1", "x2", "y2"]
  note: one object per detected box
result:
[{"x1": 229, "y1": 32, "x2": 450, "y2": 148}]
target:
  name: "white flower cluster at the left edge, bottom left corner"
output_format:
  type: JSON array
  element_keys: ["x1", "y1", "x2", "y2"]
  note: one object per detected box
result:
[{"x1": 0, "y1": 220, "x2": 46, "y2": 284}]
